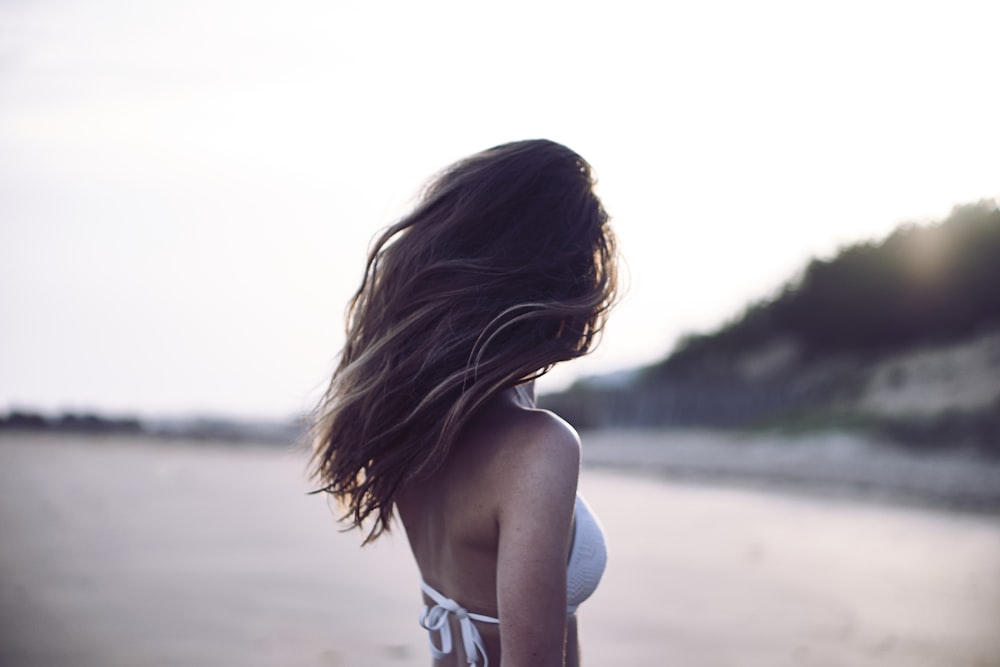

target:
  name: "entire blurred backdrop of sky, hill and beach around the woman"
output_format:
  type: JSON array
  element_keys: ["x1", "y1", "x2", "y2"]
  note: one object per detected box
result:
[{"x1": 0, "y1": 0, "x2": 1000, "y2": 665}]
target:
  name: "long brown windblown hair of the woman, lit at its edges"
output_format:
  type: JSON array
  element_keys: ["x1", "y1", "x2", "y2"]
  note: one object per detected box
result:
[{"x1": 311, "y1": 140, "x2": 617, "y2": 543}]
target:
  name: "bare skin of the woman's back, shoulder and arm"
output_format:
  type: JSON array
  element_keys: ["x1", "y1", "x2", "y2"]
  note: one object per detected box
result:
[{"x1": 396, "y1": 390, "x2": 580, "y2": 665}]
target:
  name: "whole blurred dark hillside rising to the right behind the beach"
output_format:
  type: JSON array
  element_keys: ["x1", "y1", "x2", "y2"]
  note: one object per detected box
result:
[{"x1": 543, "y1": 202, "x2": 1000, "y2": 453}]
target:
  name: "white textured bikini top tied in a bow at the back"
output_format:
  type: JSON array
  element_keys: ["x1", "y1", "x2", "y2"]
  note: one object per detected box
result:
[{"x1": 420, "y1": 495, "x2": 608, "y2": 667}]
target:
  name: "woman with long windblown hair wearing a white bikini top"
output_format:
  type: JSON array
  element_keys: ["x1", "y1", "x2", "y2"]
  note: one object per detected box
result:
[{"x1": 312, "y1": 140, "x2": 616, "y2": 667}]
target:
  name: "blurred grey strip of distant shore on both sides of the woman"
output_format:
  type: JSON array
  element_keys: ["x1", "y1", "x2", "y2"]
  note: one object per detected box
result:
[{"x1": 0, "y1": 429, "x2": 1000, "y2": 516}]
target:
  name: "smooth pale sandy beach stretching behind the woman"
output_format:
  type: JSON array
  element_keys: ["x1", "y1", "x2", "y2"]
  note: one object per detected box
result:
[{"x1": 0, "y1": 434, "x2": 1000, "y2": 667}]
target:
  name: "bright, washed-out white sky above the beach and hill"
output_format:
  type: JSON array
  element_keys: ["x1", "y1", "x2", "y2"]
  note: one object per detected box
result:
[{"x1": 0, "y1": 0, "x2": 1000, "y2": 417}]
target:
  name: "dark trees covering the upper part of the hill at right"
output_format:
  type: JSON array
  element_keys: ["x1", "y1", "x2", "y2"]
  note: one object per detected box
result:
[{"x1": 649, "y1": 202, "x2": 1000, "y2": 377}]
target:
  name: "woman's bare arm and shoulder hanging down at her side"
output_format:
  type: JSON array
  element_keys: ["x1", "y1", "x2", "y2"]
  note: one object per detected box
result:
[{"x1": 497, "y1": 412, "x2": 580, "y2": 667}]
